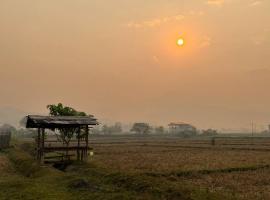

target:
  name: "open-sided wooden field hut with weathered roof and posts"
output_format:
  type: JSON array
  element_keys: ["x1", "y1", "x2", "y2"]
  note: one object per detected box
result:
[{"x1": 26, "y1": 115, "x2": 98, "y2": 163}]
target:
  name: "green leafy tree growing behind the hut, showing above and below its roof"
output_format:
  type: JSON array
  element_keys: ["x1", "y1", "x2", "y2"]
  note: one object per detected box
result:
[{"x1": 47, "y1": 103, "x2": 87, "y2": 154}]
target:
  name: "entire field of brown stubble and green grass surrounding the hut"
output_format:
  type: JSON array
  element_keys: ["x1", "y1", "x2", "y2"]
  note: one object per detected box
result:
[{"x1": 0, "y1": 136, "x2": 270, "y2": 200}]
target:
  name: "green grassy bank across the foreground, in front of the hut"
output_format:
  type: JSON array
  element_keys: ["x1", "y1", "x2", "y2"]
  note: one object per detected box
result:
[{"x1": 0, "y1": 145, "x2": 236, "y2": 200}]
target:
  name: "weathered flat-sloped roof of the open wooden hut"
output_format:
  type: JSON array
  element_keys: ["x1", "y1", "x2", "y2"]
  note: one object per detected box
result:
[{"x1": 26, "y1": 115, "x2": 98, "y2": 128}]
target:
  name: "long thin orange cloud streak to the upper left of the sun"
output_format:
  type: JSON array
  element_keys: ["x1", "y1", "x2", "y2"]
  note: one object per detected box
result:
[{"x1": 127, "y1": 15, "x2": 185, "y2": 28}]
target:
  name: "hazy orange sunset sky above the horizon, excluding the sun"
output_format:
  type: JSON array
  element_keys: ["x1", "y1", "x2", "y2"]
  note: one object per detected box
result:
[{"x1": 0, "y1": 0, "x2": 270, "y2": 130}]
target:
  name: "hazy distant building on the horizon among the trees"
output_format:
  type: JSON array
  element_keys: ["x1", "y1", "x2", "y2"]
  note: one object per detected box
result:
[{"x1": 168, "y1": 122, "x2": 196, "y2": 135}]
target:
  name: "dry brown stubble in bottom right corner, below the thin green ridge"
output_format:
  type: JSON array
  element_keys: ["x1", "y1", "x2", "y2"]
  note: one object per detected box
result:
[{"x1": 181, "y1": 169, "x2": 270, "y2": 200}]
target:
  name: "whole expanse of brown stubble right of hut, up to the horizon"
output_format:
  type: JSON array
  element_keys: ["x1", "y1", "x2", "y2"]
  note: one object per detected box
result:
[{"x1": 88, "y1": 135, "x2": 270, "y2": 199}]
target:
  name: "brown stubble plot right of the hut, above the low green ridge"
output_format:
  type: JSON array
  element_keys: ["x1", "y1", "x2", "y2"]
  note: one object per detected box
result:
[{"x1": 95, "y1": 145, "x2": 270, "y2": 172}]
